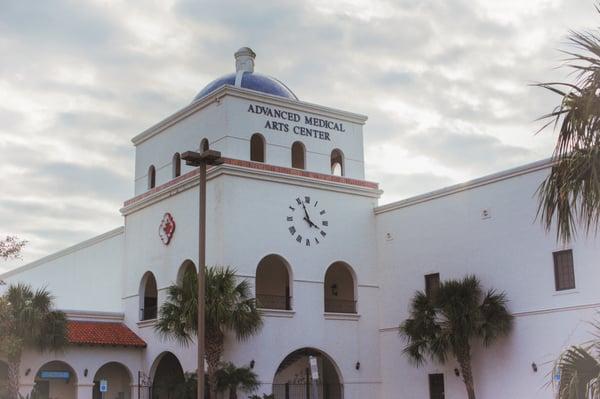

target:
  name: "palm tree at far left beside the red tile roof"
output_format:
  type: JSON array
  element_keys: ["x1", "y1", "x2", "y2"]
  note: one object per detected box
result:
[{"x1": 0, "y1": 283, "x2": 67, "y2": 399}]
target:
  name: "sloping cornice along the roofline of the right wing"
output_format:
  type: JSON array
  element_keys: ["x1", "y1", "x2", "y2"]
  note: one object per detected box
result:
[{"x1": 375, "y1": 158, "x2": 552, "y2": 214}]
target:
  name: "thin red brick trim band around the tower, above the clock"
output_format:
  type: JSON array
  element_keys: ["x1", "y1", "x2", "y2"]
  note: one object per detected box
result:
[{"x1": 124, "y1": 158, "x2": 379, "y2": 207}]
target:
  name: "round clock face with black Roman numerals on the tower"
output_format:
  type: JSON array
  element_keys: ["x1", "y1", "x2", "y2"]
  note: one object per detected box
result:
[{"x1": 286, "y1": 196, "x2": 329, "y2": 247}]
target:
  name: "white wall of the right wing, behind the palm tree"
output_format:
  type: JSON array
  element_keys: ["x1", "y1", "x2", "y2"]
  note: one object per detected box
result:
[{"x1": 377, "y1": 170, "x2": 600, "y2": 398}]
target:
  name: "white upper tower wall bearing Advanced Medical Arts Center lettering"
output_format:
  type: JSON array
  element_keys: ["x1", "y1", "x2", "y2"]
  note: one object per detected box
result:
[{"x1": 135, "y1": 94, "x2": 364, "y2": 195}]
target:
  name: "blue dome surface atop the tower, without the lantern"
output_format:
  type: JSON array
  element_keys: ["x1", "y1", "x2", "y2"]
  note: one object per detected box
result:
[{"x1": 194, "y1": 71, "x2": 298, "y2": 101}]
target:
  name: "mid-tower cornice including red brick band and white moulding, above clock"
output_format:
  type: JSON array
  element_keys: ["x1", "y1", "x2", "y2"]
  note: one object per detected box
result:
[{"x1": 121, "y1": 158, "x2": 382, "y2": 216}]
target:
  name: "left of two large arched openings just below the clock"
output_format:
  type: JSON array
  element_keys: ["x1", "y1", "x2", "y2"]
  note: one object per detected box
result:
[{"x1": 256, "y1": 255, "x2": 292, "y2": 310}]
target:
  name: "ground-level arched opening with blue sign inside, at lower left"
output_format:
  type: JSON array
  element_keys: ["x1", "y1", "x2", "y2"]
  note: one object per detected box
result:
[{"x1": 31, "y1": 360, "x2": 77, "y2": 399}]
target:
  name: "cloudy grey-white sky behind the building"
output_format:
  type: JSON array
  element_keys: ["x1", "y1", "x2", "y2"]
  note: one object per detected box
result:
[{"x1": 0, "y1": 0, "x2": 600, "y2": 272}]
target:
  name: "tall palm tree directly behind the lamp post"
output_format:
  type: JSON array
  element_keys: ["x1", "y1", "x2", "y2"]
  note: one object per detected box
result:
[{"x1": 155, "y1": 267, "x2": 262, "y2": 399}]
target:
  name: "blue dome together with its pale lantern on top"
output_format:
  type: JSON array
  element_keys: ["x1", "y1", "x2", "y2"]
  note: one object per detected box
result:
[{"x1": 194, "y1": 47, "x2": 298, "y2": 101}]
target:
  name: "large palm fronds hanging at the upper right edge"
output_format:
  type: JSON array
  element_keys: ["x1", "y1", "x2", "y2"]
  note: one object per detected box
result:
[{"x1": 537, "y1": 6, "x2": 600, "y2": 242}]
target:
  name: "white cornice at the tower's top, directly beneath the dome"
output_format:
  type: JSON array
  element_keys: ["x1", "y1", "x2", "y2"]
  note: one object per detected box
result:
[{"x1": 131, "y1": 85, "x2": 367, "y2": 146}]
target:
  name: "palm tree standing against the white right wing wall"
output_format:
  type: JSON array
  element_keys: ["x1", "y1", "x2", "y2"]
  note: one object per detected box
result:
[{"x1": 400, "y1": 276, "x2": 513, "y2": 399}]
